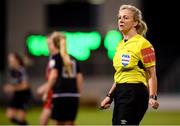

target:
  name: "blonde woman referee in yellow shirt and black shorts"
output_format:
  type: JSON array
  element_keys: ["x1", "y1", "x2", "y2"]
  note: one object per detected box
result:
[{"x1": 101, "y1": 5, "x2": 159, "y2": 125}]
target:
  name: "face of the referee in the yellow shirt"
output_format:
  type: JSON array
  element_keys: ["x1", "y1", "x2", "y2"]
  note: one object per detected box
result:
[{"x1": 118, "y1": 9, "x2": 136, "y2": 33}]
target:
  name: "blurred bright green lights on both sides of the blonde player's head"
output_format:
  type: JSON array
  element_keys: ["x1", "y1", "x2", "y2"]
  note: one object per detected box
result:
[{"x1": 26, "y1": 31, "x2": 101, "y2": 61}]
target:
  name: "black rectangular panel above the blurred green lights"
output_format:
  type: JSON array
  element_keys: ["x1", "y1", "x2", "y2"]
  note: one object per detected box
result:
[{"x1": 46, "y1": 1, "x2": 97, "y2": 30}]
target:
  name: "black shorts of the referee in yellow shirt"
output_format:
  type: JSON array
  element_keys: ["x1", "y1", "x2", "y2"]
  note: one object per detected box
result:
[{"x1": 112, "y1": 83, "x2": 149, "y2": 125}]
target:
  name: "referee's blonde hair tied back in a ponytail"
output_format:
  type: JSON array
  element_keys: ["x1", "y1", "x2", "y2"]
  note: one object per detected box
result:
[{"x1": 119, "y1": 5, "x2": 148, "y2": 36}]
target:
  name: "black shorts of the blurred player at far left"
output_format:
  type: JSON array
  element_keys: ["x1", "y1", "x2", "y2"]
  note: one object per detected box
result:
[{"x1": 8, "y1": 89, "x2": 31, "y2": 110}]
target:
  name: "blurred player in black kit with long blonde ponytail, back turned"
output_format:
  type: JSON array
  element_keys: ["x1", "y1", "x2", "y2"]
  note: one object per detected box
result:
[{"x1": 39, "y1": 32, "x2": 83, "y2": 125}]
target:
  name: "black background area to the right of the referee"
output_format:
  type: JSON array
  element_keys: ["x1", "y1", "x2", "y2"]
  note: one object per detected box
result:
[{"x1": 142, "y1": 0, "x2": 180, "y2": 92}]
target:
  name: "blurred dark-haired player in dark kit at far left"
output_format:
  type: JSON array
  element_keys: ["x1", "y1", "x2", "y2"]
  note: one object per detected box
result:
[{"x1": 4, "y1": 53, "x2": 31, "y2": 125}]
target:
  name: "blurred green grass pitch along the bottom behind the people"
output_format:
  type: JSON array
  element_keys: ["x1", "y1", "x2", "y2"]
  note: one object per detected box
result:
[{"x1": 0, "y1": 107, "x2": 180, "y2": 125}]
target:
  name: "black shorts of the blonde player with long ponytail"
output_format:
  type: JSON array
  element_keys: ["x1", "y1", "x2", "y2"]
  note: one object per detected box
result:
[{"x1": 51, "y1": 97, "x2": 79, "y2": 121}]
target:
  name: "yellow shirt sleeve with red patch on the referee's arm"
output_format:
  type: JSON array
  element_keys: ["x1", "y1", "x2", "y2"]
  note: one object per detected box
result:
[{"x1": 140, "y1": 41, "x2": 156, "y2": 68}]
